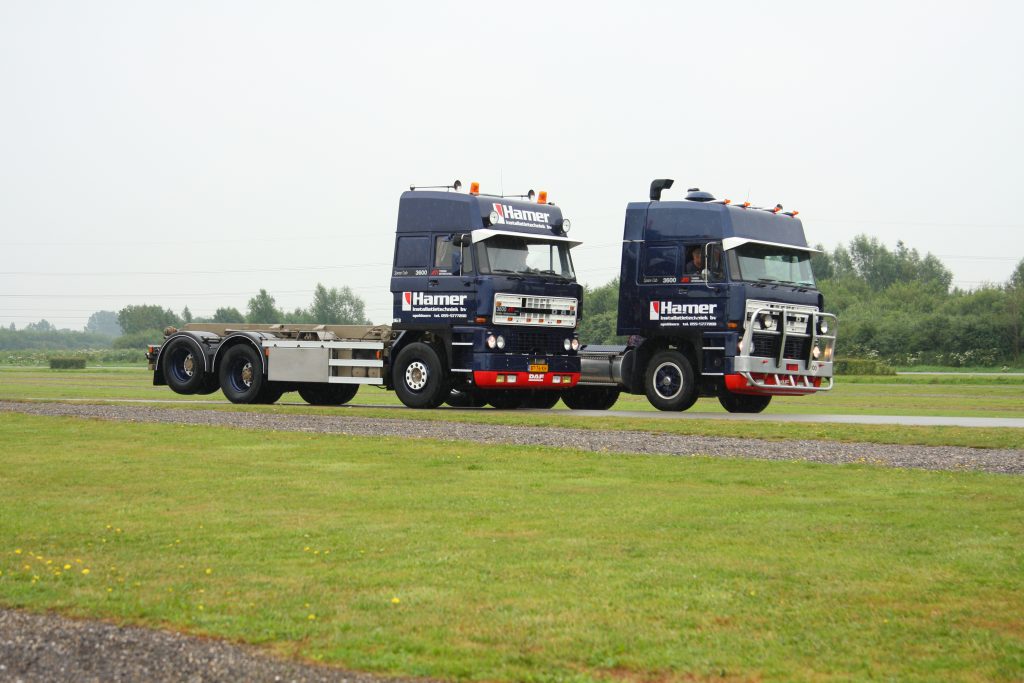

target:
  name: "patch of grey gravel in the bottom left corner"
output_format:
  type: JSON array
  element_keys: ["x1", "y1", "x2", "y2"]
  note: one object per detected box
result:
[{"x1": 0, "y1": 609, "x2": 424, "y2": 683}]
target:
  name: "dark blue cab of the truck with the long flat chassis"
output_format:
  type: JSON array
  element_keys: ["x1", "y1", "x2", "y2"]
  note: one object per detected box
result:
[{"x1": 390, "y1": 183, "x2": 582, "y2": 408}]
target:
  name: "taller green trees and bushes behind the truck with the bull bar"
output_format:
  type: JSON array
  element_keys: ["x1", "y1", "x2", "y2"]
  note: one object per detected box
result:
[{"x1": 580, "y1": 234, "x2": 1024, "y2": 367}]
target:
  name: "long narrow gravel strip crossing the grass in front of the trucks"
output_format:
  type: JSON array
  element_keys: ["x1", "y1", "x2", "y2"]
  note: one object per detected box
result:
[{"x1": 0, "y1": 401, "x2": 1024, "y2": 474}]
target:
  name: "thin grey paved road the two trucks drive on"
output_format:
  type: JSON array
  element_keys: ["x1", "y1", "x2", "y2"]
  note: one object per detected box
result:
[{"x1": 14, "y1": 398, "x2": 1024, "y2": 429}]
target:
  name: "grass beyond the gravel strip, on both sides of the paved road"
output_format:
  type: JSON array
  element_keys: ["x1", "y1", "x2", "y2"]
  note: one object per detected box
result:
[{"x1": 0, "y1": 368, "x2": 1024, "y2": 447}]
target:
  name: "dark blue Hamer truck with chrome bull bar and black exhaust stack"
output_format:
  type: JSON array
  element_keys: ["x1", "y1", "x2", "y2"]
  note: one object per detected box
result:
[{"x1": 564, "y1": 178, "x2": 836, "y2": 413}]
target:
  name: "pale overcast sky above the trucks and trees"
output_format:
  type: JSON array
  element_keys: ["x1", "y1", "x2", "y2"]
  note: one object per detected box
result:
[{"x1": 0, "y1": 0, "x2": 1024, "y2": 329}]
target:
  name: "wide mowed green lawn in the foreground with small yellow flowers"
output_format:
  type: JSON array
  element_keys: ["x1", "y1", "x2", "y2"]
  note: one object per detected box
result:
[{"x1": 0, "y1": 414, "x2": 1024, "y2": 681}]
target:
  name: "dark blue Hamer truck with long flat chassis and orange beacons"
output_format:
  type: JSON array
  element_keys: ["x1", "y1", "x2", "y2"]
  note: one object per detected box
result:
[{"x1": 147, "y1": 181, "x2": 582, "y2": 408}]
